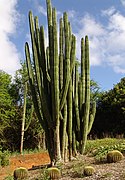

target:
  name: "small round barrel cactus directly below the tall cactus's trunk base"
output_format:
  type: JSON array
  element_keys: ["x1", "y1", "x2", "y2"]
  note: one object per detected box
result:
[{"x1": 48, "y1": 167, "x2": 61, "y2": 180}]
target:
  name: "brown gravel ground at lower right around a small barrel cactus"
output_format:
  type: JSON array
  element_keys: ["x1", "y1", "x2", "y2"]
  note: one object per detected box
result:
[{"x1": 61, "y1": 156, "x2": 125, "y2": 180}]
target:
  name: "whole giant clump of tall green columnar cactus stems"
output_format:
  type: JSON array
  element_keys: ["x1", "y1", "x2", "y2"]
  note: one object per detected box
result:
[{"x1": 25, "y1": 0, "x2": 95, "y2": 161}]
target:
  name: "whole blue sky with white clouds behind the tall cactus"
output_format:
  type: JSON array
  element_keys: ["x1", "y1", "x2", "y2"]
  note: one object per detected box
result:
[{"x1": 0, "y1": 0, "x2": 125, "y2": 90}]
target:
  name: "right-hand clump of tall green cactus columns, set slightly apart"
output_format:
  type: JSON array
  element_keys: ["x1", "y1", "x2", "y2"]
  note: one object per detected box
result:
[{"x1": 74, "y1": 36, "x2": 96, "y2": 154}]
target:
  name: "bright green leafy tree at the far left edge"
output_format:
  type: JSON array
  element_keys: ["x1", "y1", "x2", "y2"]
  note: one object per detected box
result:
[{"x1": 0, "y1": 70, "x2": 16, "y2": 149}]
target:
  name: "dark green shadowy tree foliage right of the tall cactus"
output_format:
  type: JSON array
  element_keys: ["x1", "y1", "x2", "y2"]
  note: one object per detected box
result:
[{"x1": 92, "y1": 78, "x2": 125, "y2": 138}]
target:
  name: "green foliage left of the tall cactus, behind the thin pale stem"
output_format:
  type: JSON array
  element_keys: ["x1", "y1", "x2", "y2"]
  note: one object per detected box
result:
[{"x1": 0, "y1": 63, "x2": 43, "y2": 151}]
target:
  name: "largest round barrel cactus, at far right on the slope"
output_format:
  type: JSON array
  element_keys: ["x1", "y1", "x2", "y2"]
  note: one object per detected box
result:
[{"x1": 107, "y1": 150, "x2": 123, "y2": 163}]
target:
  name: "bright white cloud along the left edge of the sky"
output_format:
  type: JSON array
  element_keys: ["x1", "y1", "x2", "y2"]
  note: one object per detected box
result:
[{"x1": 0, "y1": 0, "x2": 20, "y2": 75}]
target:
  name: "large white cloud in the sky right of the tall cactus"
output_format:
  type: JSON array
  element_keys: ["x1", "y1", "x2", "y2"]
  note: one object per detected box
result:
[{"x1": 72, "y1": 7, "x2": 125, "y2": 73}]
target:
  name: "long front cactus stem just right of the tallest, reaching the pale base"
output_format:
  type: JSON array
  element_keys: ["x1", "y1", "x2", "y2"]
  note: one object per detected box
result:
[{"x1": 51, "y1": 8, "x2": 61, "y2": 160}]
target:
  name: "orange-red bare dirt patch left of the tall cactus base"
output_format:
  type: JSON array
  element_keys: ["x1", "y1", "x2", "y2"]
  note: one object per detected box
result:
[{"x1": 0, "y1": 153, "x2": 50, "y2": 180}]
